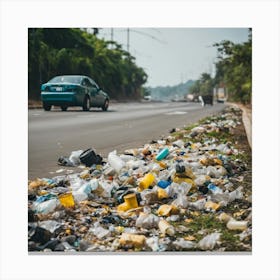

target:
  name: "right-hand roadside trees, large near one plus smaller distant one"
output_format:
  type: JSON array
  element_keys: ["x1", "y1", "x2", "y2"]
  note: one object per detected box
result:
[{"x1": 189, "y1": 29, "x2": 252, "y2": 104}]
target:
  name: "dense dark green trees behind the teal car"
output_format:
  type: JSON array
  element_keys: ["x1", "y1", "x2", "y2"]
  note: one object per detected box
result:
[{"x1": 28, "y1": 28, "x2": 147, "y2": 99}]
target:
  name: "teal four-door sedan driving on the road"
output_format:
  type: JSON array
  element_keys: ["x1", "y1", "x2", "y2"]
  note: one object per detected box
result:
[{"x1": 41, "y1": 75, "x2": 109, "y2": 111}]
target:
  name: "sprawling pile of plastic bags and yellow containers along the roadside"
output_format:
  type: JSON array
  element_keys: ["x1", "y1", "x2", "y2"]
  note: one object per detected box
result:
[{"x1": 28, "y1": 107, "x2": 252, "y2": 252}]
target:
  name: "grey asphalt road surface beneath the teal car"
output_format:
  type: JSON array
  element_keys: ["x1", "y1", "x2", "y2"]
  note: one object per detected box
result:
[{"x1": 28, "y1": 102, "x2": 225, "y2": 179}]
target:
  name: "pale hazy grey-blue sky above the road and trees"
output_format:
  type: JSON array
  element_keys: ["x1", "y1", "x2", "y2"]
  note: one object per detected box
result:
[{"x1": 98, "y1": 28, "x2": 248, "y2": 87}]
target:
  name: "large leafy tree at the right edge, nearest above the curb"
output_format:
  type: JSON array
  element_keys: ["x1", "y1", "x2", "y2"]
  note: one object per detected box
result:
[{"x1": 214, "y1": 30, "x2": 252, "y2": 104}]
